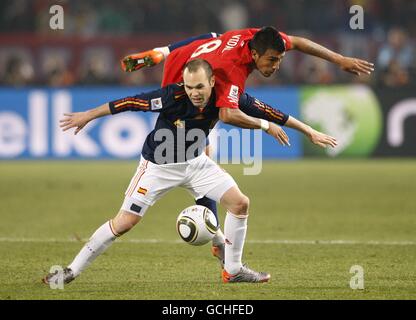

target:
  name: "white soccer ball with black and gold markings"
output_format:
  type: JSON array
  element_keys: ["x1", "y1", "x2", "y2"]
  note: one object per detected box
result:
[{"x1": 176, "y1": 205, "x2": 219, "y2": 246}]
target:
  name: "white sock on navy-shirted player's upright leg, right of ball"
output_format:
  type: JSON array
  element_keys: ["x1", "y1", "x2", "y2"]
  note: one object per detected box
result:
[{"x1": 224, "y1": 211, "x2": 247, "y2": 274}]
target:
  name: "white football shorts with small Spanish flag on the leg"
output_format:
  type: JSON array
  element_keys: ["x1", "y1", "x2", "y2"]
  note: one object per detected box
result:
[{"x1": 121, "y1": 153, "x2": 237, "y2": 215}]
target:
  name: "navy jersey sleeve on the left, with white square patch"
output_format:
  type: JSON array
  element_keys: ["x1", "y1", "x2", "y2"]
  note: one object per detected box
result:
[{"x1": 109, "y1": 84, "x2": 186, "y2": 114}]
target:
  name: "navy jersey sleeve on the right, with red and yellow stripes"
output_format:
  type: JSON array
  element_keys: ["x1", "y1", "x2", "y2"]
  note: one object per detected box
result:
[{"x1": 238, "y1": 92, "x2": 289, "y2": 126}]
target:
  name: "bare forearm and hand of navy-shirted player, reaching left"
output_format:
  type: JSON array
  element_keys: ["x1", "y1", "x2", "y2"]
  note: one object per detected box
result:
[{"x1": 59, "y1": 103, "x2": 111, "y2": 134}]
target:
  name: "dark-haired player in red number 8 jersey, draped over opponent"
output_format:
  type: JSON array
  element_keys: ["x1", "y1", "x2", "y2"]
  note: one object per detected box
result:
[{"x1": 121, "y1": 27, "x2": 364, "y2": 270}]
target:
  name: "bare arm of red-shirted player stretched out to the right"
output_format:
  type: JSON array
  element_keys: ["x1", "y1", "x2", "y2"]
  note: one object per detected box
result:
[{"x1": 289, "y1": 36, "x2": 374, "y2": 76}]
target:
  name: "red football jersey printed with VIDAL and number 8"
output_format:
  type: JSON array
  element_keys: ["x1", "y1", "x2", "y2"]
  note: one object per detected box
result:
[{"x1": 162, "y1": 28, "x2": 292, "y2": 108}]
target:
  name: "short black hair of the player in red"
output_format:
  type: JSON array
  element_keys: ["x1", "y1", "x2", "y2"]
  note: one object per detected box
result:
[{"x1": 248, "y1": 27, "x2": 285, "y2": 56}]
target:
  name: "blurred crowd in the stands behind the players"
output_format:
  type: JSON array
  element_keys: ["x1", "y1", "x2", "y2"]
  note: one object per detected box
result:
[{"x1": 0, "y1": 0, "x2": 416, "y2": 87}]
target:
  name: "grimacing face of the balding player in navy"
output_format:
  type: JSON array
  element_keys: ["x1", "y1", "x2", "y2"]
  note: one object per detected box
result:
[{"x1": 183, "y1": 68, "x2": 215, "y2": 108}]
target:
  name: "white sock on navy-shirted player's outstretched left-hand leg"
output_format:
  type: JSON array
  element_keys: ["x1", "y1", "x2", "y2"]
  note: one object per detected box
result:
[{"x1": 68, "y1": 221, "x2": 116, "y2": 277}]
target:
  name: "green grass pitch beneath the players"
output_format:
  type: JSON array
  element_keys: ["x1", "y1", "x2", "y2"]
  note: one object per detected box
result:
[{"x1": 0, "y1": 159, "x2": 416, "y2": 300}]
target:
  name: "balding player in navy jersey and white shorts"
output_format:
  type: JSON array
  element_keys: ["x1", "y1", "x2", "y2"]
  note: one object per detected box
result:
[{"x1": 43, "y1": 59, "x2": 336, "y2": 284}]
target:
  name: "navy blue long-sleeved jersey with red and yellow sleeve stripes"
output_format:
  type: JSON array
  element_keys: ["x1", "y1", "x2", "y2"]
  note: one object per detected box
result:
[{"x1": 109, "y1": 83, "x2": 288, "y2": 164}]
